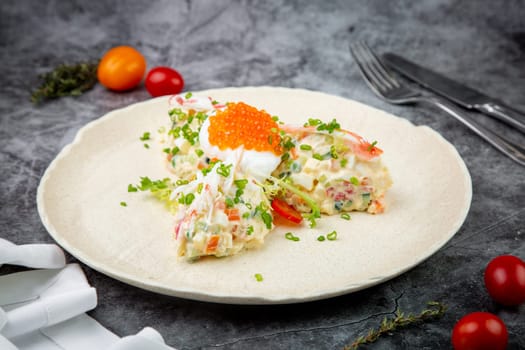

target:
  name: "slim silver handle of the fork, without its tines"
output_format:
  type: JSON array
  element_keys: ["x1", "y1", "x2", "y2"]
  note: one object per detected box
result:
[{"x1": 423, "y1": 97, "x2": 525, "y2": 166}]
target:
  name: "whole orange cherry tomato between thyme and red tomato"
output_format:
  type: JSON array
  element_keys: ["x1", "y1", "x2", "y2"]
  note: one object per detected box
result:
[{"x1": 97, "y1": 46, "x2": 146, "y2": 91}]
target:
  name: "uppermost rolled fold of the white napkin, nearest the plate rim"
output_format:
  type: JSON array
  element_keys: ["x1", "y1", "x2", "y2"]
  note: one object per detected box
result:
[{"x1": 0, "y1": 238, "x2": 66, "y2": 269}]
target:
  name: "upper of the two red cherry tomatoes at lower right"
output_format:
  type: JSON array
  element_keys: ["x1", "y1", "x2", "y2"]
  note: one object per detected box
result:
[{"x1": 485, "y1": 255, "x2": 525, "y2": 306}]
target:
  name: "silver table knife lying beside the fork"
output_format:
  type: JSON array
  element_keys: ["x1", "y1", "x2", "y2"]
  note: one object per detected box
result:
[{"x1": 383, "y1": 53, "x2": 525, "y2": 133}]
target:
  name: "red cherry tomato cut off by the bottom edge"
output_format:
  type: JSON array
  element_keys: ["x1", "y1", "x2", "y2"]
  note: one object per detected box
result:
[{"x1": 452, "y1": 312, "x2": 509, "y2": 350}]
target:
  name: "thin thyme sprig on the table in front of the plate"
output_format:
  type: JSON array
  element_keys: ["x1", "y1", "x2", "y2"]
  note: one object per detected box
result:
[{"x1": 344, "y1": 301, "x2": 447, "y2": 350}]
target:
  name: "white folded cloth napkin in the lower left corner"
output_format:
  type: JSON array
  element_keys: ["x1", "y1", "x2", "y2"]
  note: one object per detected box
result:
[{"x1": 0, "y1": 238, "x2": 174, "y2": 350}]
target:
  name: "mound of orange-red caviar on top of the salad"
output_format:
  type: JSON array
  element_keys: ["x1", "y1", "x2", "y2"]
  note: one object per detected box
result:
[{"x1": 208, "y1": 102, "x2": 282, "y2": 155}]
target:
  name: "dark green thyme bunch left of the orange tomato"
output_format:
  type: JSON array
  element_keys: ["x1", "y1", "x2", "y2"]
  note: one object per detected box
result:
[{"x1": 31, "y1": 62, "x2": 98, "y2": 104}]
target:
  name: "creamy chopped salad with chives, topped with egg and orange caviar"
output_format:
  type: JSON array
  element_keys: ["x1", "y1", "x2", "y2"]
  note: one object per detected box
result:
[{"x1": 128, "y1": 93, "x2": 392, "y2": 261}]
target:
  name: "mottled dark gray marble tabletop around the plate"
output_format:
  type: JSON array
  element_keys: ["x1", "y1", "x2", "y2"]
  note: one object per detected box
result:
[{"x1": 0, "y1": 0, "x2": 525, "y2": 350}]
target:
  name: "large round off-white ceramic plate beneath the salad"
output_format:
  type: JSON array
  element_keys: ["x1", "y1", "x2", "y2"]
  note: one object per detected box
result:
[{"x1": 37, "y1": 87, "x2": 472, "y2": 304}]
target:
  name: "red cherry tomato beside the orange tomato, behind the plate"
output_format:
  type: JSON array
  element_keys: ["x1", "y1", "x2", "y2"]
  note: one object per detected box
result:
[{"x1": 146, "y1": 67, "x2": 184, "y2": 97}]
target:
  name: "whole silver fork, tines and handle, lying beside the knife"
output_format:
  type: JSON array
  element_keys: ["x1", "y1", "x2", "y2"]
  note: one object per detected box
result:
[{"x1": 350, "y1": 42, "x2": 525, "y2": 166}]
